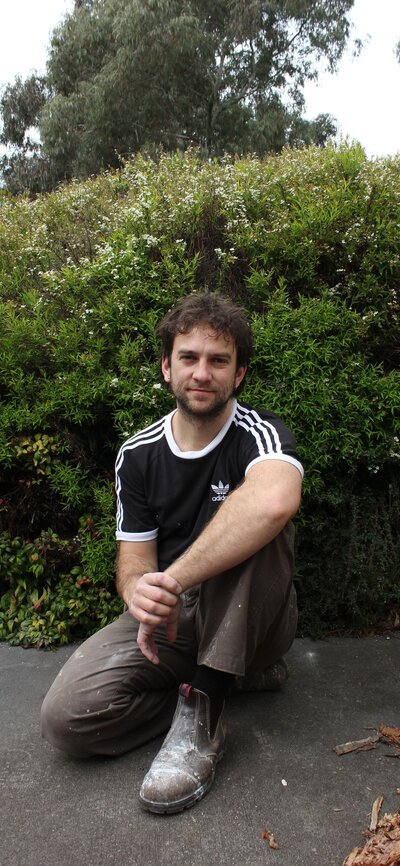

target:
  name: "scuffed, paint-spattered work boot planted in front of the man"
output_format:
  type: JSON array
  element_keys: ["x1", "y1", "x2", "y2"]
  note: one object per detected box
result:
[{"x1": 139, "y1": 684, "x2": 225, "y2": 813}]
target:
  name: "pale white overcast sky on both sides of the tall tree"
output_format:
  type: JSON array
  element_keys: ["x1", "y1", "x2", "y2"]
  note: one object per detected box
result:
[{"x1": 0, "y1": 0, "x2": 400, "y2": 156}]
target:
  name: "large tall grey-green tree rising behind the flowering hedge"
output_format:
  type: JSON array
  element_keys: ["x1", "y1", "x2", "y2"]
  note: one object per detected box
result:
[{"x1": 0, "y1": 0, "x2": 354, "y2": 191}]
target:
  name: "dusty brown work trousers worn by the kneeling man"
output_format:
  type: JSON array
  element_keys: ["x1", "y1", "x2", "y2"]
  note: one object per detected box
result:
[{"x1": 41, "y1": 523, "x2": 297, "y2": 758}]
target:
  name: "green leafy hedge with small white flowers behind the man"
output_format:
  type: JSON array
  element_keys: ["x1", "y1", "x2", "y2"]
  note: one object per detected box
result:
[{"x1": 0, "y1": 146, "x2": 400, "y2": 645}]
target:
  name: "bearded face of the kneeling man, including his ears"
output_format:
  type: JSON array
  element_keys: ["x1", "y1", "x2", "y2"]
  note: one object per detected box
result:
[{"x1": 161, "y1": 325, "x2": 246, "y2": 418}]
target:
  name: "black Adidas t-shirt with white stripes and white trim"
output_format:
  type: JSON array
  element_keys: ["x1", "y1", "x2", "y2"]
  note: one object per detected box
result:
[{"x1": 116, "y1": 400, "x2": 303, "y2": 570}]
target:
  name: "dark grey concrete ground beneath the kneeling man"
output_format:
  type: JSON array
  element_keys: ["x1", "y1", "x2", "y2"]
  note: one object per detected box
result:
[{"x1": 0, "y1": 632, "x2": 400, "y2": 866}]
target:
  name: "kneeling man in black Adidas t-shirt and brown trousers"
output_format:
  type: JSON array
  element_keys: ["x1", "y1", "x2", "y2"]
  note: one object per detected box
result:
[{"x1": 42, "y1": 294, "x2": 302, "y2": 813}]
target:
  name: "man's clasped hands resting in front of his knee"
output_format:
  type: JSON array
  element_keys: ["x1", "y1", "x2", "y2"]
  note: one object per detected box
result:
[{"x1": 127, "y1": 571, "x2": 182, "y2": 665}]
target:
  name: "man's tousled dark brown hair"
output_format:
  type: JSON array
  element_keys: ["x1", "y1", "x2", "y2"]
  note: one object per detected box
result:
[{"x1": 156, "y1": 292, "x2": 253, "y2": 367}]
